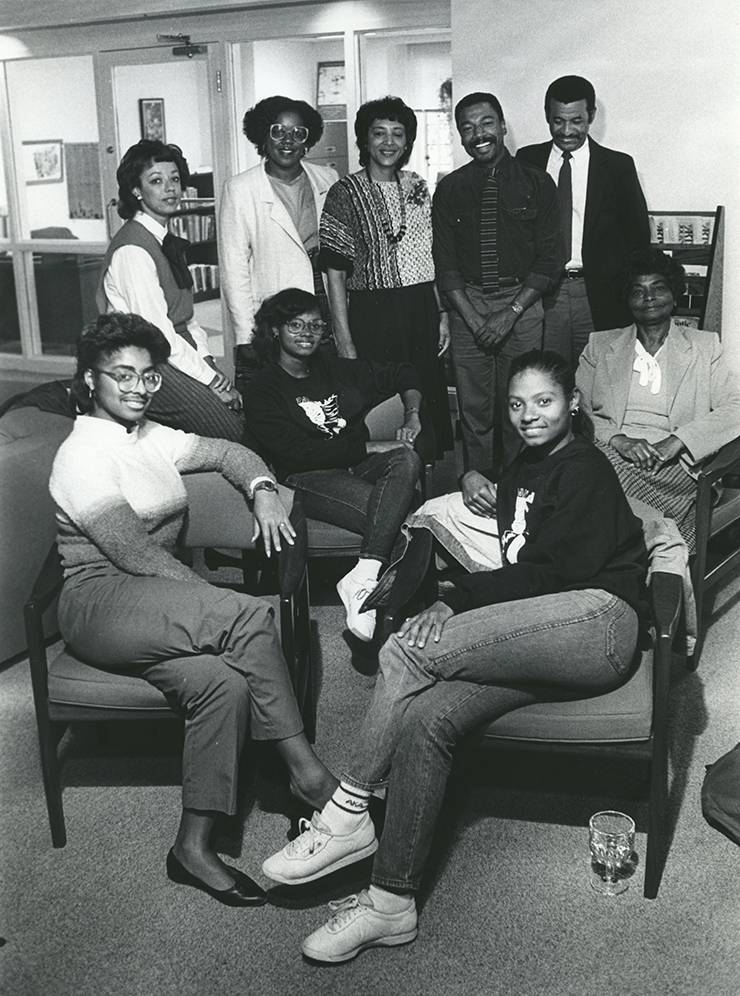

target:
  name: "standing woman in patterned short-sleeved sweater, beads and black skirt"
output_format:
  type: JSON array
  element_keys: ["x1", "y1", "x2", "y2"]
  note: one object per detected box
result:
[{"x1": 319, "y1": 97, "x2": 452, "y2": 456}]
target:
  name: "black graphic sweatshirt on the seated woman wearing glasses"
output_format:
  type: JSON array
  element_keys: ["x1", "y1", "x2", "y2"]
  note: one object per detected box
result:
[{"x1": 244, "y1": 356, "x2": 419, "y2": 481}]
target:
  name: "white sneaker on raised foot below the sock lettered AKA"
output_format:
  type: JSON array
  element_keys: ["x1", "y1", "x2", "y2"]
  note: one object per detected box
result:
[{"x1": 262, "y1": 813, "x2": 378, "y2": 885}]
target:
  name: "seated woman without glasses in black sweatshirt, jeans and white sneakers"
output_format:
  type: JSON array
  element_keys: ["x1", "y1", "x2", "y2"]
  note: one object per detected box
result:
[{"x1": 262, "y1": 352, "x2": 647, "y2": 962}]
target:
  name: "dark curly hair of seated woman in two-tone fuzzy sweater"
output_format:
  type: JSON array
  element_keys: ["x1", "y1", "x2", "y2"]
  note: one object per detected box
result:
[{"x1": 71, "y1": 311, "x2": 170, "y2": 413}]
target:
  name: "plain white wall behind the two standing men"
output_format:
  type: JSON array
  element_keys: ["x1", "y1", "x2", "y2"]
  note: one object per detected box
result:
[{"x1": 451, "y1": 0, "x2": 740, "y2": 371}]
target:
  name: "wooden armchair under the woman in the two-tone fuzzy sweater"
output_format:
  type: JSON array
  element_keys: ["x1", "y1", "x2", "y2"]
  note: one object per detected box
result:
[{"x1": 24, "y1": 473, "x2": 315, "y2": 847}]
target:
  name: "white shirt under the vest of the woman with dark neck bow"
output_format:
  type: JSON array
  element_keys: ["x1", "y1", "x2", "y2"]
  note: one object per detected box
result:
[{"x1": 103, "y1": 211, "x2": 216, "y2": 384}]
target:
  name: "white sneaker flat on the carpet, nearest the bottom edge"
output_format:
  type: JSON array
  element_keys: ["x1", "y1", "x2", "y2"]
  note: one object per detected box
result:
[{"x1": 301, "y1": 889, "x2": 417, "y2": 962}]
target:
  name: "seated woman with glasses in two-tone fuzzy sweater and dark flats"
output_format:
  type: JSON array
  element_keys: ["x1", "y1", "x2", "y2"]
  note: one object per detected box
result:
[{"x1": 49, "y1": 313, "x2": 336, "y2": 906}]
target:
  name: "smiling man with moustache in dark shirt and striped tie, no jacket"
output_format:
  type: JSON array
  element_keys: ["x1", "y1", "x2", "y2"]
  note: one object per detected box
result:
[{"x1": 432, "y1": 93, "x2": 564, "y2": 472}]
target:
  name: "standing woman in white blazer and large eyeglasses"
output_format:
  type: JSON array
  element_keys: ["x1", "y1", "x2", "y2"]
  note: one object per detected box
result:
[{"x1": 218, "y1": 96, "x2": 338, "y2": 391}]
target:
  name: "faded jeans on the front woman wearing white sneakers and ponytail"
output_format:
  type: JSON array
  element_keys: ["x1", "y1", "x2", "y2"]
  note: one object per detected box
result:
[{"x1": 342, "y1": 589, "x2": 638, "y2": 891}]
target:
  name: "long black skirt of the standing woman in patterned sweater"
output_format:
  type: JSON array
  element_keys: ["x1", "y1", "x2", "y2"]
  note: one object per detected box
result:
[{"x1": 349, "y1": 283, "x2": 453, "y2": 458}]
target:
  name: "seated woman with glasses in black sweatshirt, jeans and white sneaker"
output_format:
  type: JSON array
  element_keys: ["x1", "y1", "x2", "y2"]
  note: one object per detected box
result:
[{"x1": 244, "y1": 287, "x2": 421, "y2": 640}]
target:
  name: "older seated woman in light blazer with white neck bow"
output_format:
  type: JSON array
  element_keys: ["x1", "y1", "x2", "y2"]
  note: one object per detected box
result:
[{"x1": 576, "y1": 249, "x2": 740, "y2": 552}]
